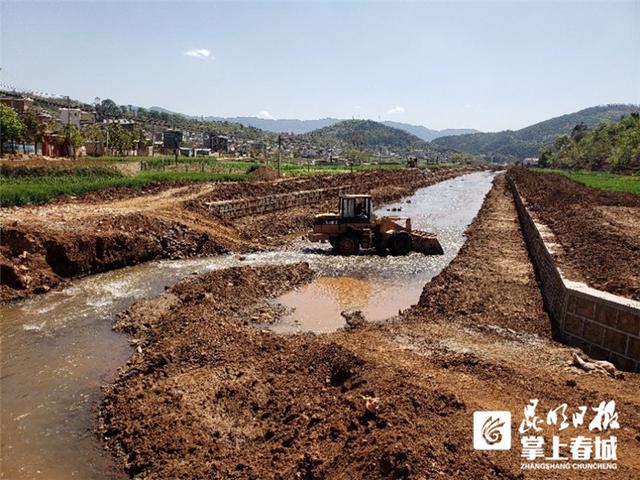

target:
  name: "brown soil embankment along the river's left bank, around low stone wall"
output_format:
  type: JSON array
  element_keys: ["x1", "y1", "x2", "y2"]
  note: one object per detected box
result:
[{"x1": 0, "y1": 167, "x2": 473, "y2": 301}]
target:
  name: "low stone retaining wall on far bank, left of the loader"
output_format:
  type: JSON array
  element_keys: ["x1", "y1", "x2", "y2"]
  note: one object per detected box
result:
[{"x1": 205, "y1": 185, "x2": 352, "y2": 219}]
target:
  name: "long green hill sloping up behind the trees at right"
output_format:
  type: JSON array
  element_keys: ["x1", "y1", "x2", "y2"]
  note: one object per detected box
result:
[{"x1": 433, "y1": 105, "x2": 640, "y2": 159}]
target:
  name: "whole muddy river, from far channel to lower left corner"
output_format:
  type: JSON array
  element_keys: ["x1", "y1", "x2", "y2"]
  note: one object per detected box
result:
[{"x1": 0, "y1": 172, "x2": 493, "y2": 480}]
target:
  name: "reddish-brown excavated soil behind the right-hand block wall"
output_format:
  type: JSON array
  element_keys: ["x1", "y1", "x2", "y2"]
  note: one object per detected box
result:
[{"x1": 509, "y1": 168, "x2": 640, "y2": 300}]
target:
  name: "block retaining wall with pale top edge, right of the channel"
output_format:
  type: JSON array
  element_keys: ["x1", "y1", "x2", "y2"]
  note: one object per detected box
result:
[{"x1": 508, "y1": 178, "x2": 640, "y2": 372}]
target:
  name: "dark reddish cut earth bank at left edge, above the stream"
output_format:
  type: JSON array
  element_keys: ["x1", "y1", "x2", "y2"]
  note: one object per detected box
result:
[{"x1": 0, "y1": 214, "x2": 226, "y2": 301}]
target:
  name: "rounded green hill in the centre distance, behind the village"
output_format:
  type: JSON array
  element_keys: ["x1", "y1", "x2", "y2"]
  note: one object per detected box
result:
[{"x1": 299, "y1": 120, "x2": 433, "y2": 153}]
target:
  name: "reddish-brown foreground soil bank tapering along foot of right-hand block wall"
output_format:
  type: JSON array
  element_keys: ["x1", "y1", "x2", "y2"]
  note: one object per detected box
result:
[{"x1": 101, "y1": 177, "x2": 640, "y2": 479}]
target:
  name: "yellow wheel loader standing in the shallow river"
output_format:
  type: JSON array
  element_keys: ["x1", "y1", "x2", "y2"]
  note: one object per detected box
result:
[{"x1": 309, "y1": 195, "x2": 444, "y2": 255}]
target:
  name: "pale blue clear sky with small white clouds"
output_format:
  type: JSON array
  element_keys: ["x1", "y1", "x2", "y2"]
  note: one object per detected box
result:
[{"x1": 0, "y1": 0, "x2": 640, "y2": 131}]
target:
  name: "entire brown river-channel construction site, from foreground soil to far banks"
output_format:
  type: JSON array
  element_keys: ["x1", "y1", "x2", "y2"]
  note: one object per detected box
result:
[{"x1": 0, "y1": 166, "x2": 640, "y2": 479}]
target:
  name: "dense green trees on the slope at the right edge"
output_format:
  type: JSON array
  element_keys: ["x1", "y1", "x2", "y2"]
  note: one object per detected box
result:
[{"x1": 540, "y1": 113, "x2": 640, "y2": 172}]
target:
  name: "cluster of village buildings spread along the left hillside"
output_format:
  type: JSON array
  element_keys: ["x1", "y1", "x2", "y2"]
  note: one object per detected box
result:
[{"x1": 0, "y1": 94, "x2": 444, "y2": 164}]
